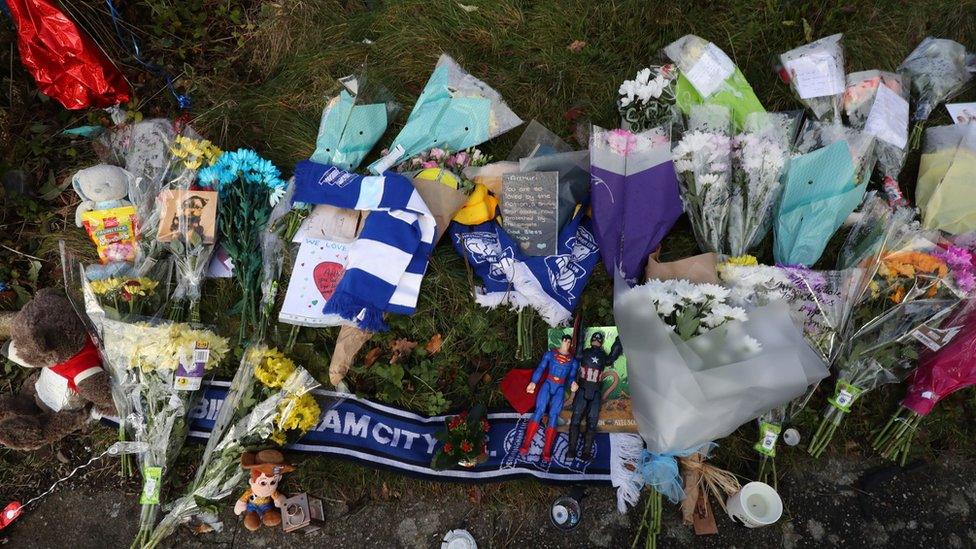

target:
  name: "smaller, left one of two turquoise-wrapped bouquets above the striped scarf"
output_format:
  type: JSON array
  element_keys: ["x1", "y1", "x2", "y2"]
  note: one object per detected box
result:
[{"x1": 311, "y1": 70, "x2": 400, "y2": 172}]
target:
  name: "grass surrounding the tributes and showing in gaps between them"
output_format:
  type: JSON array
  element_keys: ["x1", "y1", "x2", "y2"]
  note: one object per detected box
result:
[{"x1": 0, "y1": 0, "x2": 976, "y2": 540}]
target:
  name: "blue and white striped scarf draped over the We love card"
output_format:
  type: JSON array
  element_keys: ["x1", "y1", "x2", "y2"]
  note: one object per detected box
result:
[{"x1": 293, "y1": 160, "x2": 435, "y2": 332}]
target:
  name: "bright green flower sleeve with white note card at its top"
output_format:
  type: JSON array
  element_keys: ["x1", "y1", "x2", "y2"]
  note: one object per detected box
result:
[{"x1": 664, "y1": 34, "x2": 765, "y2": 128}]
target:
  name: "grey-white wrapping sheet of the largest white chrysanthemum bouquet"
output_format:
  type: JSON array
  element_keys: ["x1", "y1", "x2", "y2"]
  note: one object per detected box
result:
[{"x1": 614, "y1": 282, "x2": 826, "y2": 454}]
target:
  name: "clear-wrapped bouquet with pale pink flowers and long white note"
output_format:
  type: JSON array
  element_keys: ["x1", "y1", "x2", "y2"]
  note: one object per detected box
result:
[{"x1": 844, "y1": 70, "x2": 909, "y2": 202}]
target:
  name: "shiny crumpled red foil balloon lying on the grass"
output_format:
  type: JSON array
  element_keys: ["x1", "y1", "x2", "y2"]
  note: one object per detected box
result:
[{"x1": 7, "y1": 0, "x2": 131, "y2": 110}]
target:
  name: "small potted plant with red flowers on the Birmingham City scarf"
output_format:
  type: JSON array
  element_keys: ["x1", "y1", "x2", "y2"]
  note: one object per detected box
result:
[{"x1": 430, "y1": 404, "x2": 490, "y2": 470}]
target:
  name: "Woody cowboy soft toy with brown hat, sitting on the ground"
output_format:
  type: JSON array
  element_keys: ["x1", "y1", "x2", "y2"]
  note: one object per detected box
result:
[{"x1": 234, "y1": 450, "x2": 295, "y2": 532}]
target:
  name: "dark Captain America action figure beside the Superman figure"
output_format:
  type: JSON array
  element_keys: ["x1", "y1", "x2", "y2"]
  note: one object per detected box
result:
[{"x1": 567, "y1": 332, "x2": 624, "y2": 461}]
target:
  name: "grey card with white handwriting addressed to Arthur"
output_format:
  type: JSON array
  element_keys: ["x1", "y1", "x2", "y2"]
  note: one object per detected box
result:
[{"x1": 502, "y1": 172, "x2": 559, "y2": 255}]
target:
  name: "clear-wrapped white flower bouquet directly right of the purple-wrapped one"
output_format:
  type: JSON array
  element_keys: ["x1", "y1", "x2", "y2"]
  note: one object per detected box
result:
[{"x1": 672, "y1": 105, "x2": 732, "y2": 252}]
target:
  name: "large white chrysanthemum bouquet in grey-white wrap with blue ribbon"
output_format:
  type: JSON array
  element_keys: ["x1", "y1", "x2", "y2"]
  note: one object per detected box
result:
[{"x1": 614, "y1": 272, "x2": 827, "y2": 544}]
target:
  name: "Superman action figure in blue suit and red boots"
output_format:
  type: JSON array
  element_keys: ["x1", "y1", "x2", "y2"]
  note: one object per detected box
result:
[{"x1": 519, "y1": 335, "x2": 579, "y2": 461}]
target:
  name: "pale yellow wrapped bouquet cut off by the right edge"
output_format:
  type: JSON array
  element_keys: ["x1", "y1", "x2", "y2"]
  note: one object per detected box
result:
[{"x1": 915, "y1": 124, "x2": 976, "y2": 235}]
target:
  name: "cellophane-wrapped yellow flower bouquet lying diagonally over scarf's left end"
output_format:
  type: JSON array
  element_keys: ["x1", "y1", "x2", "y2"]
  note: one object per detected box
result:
[{"x1": 146, "y1": 345, "x2": 319, "y2": 547}]
